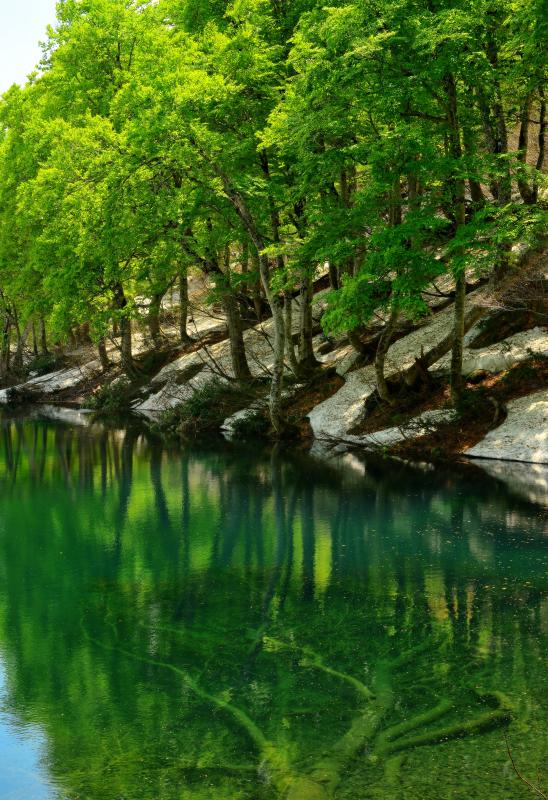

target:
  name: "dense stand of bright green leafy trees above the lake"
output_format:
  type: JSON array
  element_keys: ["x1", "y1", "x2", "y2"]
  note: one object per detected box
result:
[{"x1": 0, "y1": 0, "x2": 548, "y2": 434}]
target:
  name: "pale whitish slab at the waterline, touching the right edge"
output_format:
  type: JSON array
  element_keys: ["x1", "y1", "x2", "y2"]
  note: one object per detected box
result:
[{"x1": 466, "y1": 389, "x2": 548, "y2": 464}]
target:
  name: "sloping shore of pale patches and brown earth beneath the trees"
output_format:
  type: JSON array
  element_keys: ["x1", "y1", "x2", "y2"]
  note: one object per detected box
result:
[{"x1": 0, "y1": 288, "x2": 548, "y2": 465}]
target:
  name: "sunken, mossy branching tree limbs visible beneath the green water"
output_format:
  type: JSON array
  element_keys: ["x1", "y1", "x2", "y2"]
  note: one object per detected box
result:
[{"x1": 84, "y1": 631, "x2": 512, "y2": 800}]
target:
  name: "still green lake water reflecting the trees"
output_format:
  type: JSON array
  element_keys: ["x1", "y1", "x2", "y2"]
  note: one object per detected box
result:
[{"x1": 0, "y1": 418, "x2": 548, "y2": 800}]
